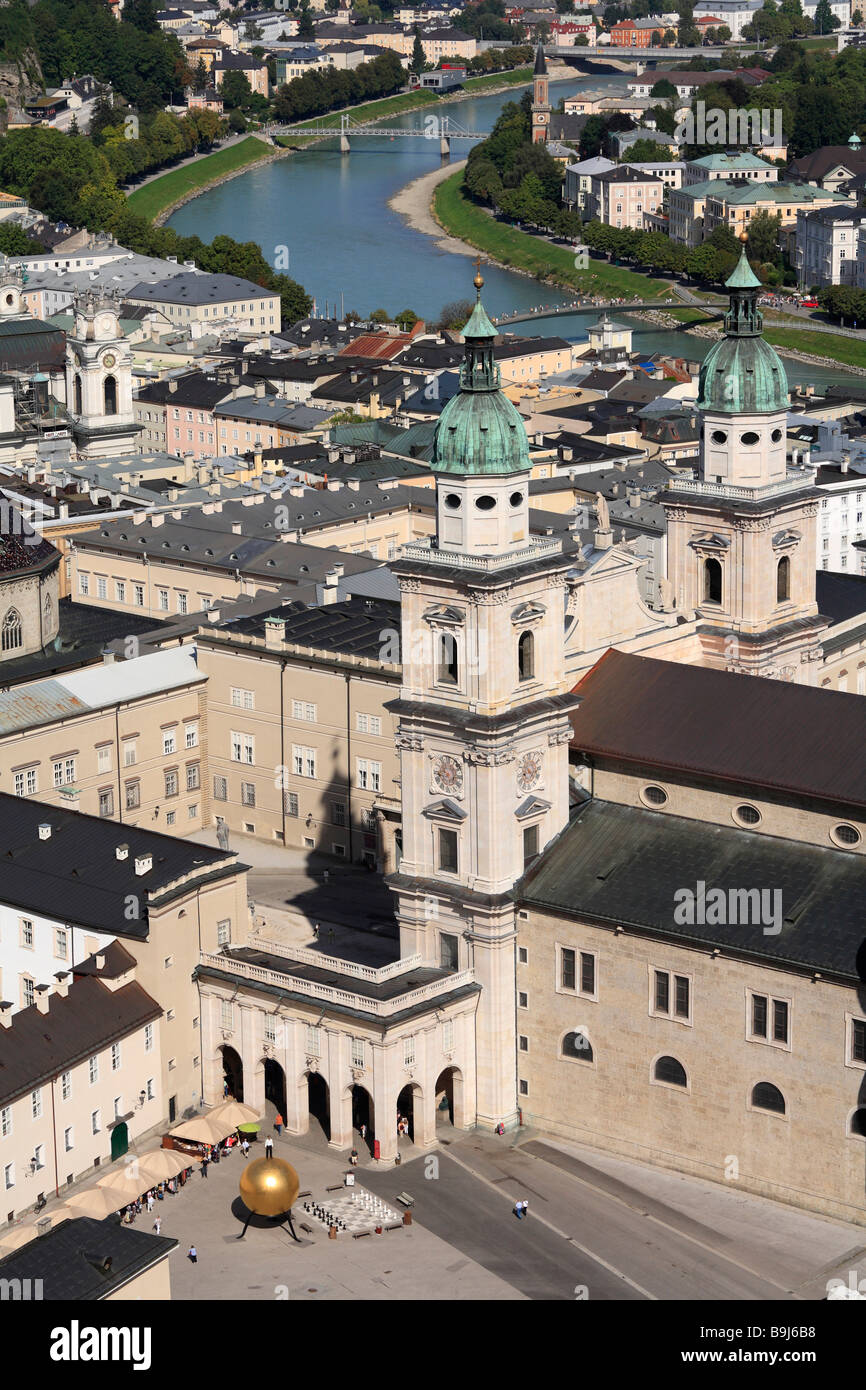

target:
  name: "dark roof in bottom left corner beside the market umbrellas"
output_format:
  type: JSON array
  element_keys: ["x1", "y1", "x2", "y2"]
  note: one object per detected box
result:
[{"x1": 0, "y1": 1216, "x2": 178, "y2": 1302}]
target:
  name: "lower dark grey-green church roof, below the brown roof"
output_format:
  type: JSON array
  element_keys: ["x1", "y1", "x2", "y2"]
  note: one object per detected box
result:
[{"x1": 516, "y1": 800, "x2": 866, "y2": 979}]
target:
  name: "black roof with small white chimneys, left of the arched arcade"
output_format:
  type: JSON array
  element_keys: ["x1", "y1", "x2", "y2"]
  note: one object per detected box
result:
[{"x1": 0, "y1": 792, "x2": 242, "y2": 938}]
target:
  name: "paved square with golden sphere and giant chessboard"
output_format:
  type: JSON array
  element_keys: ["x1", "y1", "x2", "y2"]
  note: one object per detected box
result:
[{"x1": 52, "y1": 1130, "x2": 866, "y2": 1301}]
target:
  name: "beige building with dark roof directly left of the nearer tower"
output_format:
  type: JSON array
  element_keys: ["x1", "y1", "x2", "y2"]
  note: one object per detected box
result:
[{"x1": 196, "y1": 599, "x2": 402, "y2": 869}]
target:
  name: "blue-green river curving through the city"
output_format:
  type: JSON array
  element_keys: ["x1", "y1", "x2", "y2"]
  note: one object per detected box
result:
[{"x1": 168, "y1": 75, "x2": 856, "y2": 385}]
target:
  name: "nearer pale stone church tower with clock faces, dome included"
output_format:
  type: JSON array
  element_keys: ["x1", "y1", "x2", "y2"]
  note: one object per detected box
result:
[{"x1": 389, "y1": 275, "x2": 577, "y2": 1129}]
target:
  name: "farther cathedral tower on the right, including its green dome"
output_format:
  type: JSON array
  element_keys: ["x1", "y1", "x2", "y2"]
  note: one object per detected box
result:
[{"x1": 662, "y1": 239, "x2": 826, "y2": 684}]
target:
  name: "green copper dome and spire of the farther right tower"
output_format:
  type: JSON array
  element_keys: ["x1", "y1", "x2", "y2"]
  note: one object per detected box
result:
[{"x1": 698, "y1": 243, "x2": 788, "y2": 416}]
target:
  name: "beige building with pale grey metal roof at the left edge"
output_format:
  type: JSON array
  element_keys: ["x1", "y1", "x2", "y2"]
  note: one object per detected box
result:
[{"x1": 0, "y1": 650, "x2": 207, "y2": 835}]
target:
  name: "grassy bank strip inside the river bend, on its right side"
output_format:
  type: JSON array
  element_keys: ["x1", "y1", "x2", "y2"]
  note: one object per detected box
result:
[{"x1": 432, "y1": 170, "x2": 673, "y2": 298}]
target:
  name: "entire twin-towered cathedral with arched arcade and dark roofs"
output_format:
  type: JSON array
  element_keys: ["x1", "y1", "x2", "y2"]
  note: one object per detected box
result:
[{"x1": 197, "y1": 247, "x2": 866, "y2": 1223}]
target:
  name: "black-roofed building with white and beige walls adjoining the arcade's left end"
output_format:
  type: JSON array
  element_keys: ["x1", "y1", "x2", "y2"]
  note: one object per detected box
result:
[{"x1": 0, "y1": 794, "x2": 249, "y2": 1123}]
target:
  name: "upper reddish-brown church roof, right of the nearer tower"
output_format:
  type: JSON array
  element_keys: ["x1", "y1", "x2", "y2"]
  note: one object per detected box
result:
[{"x1": 573, "y1": 649, "x2": 866, "y2": 811}]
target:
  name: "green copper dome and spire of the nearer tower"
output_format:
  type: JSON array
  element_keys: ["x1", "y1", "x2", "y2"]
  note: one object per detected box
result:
[{"x1": 431, "y1": 275, "x2": 531, "y2": 477}]
